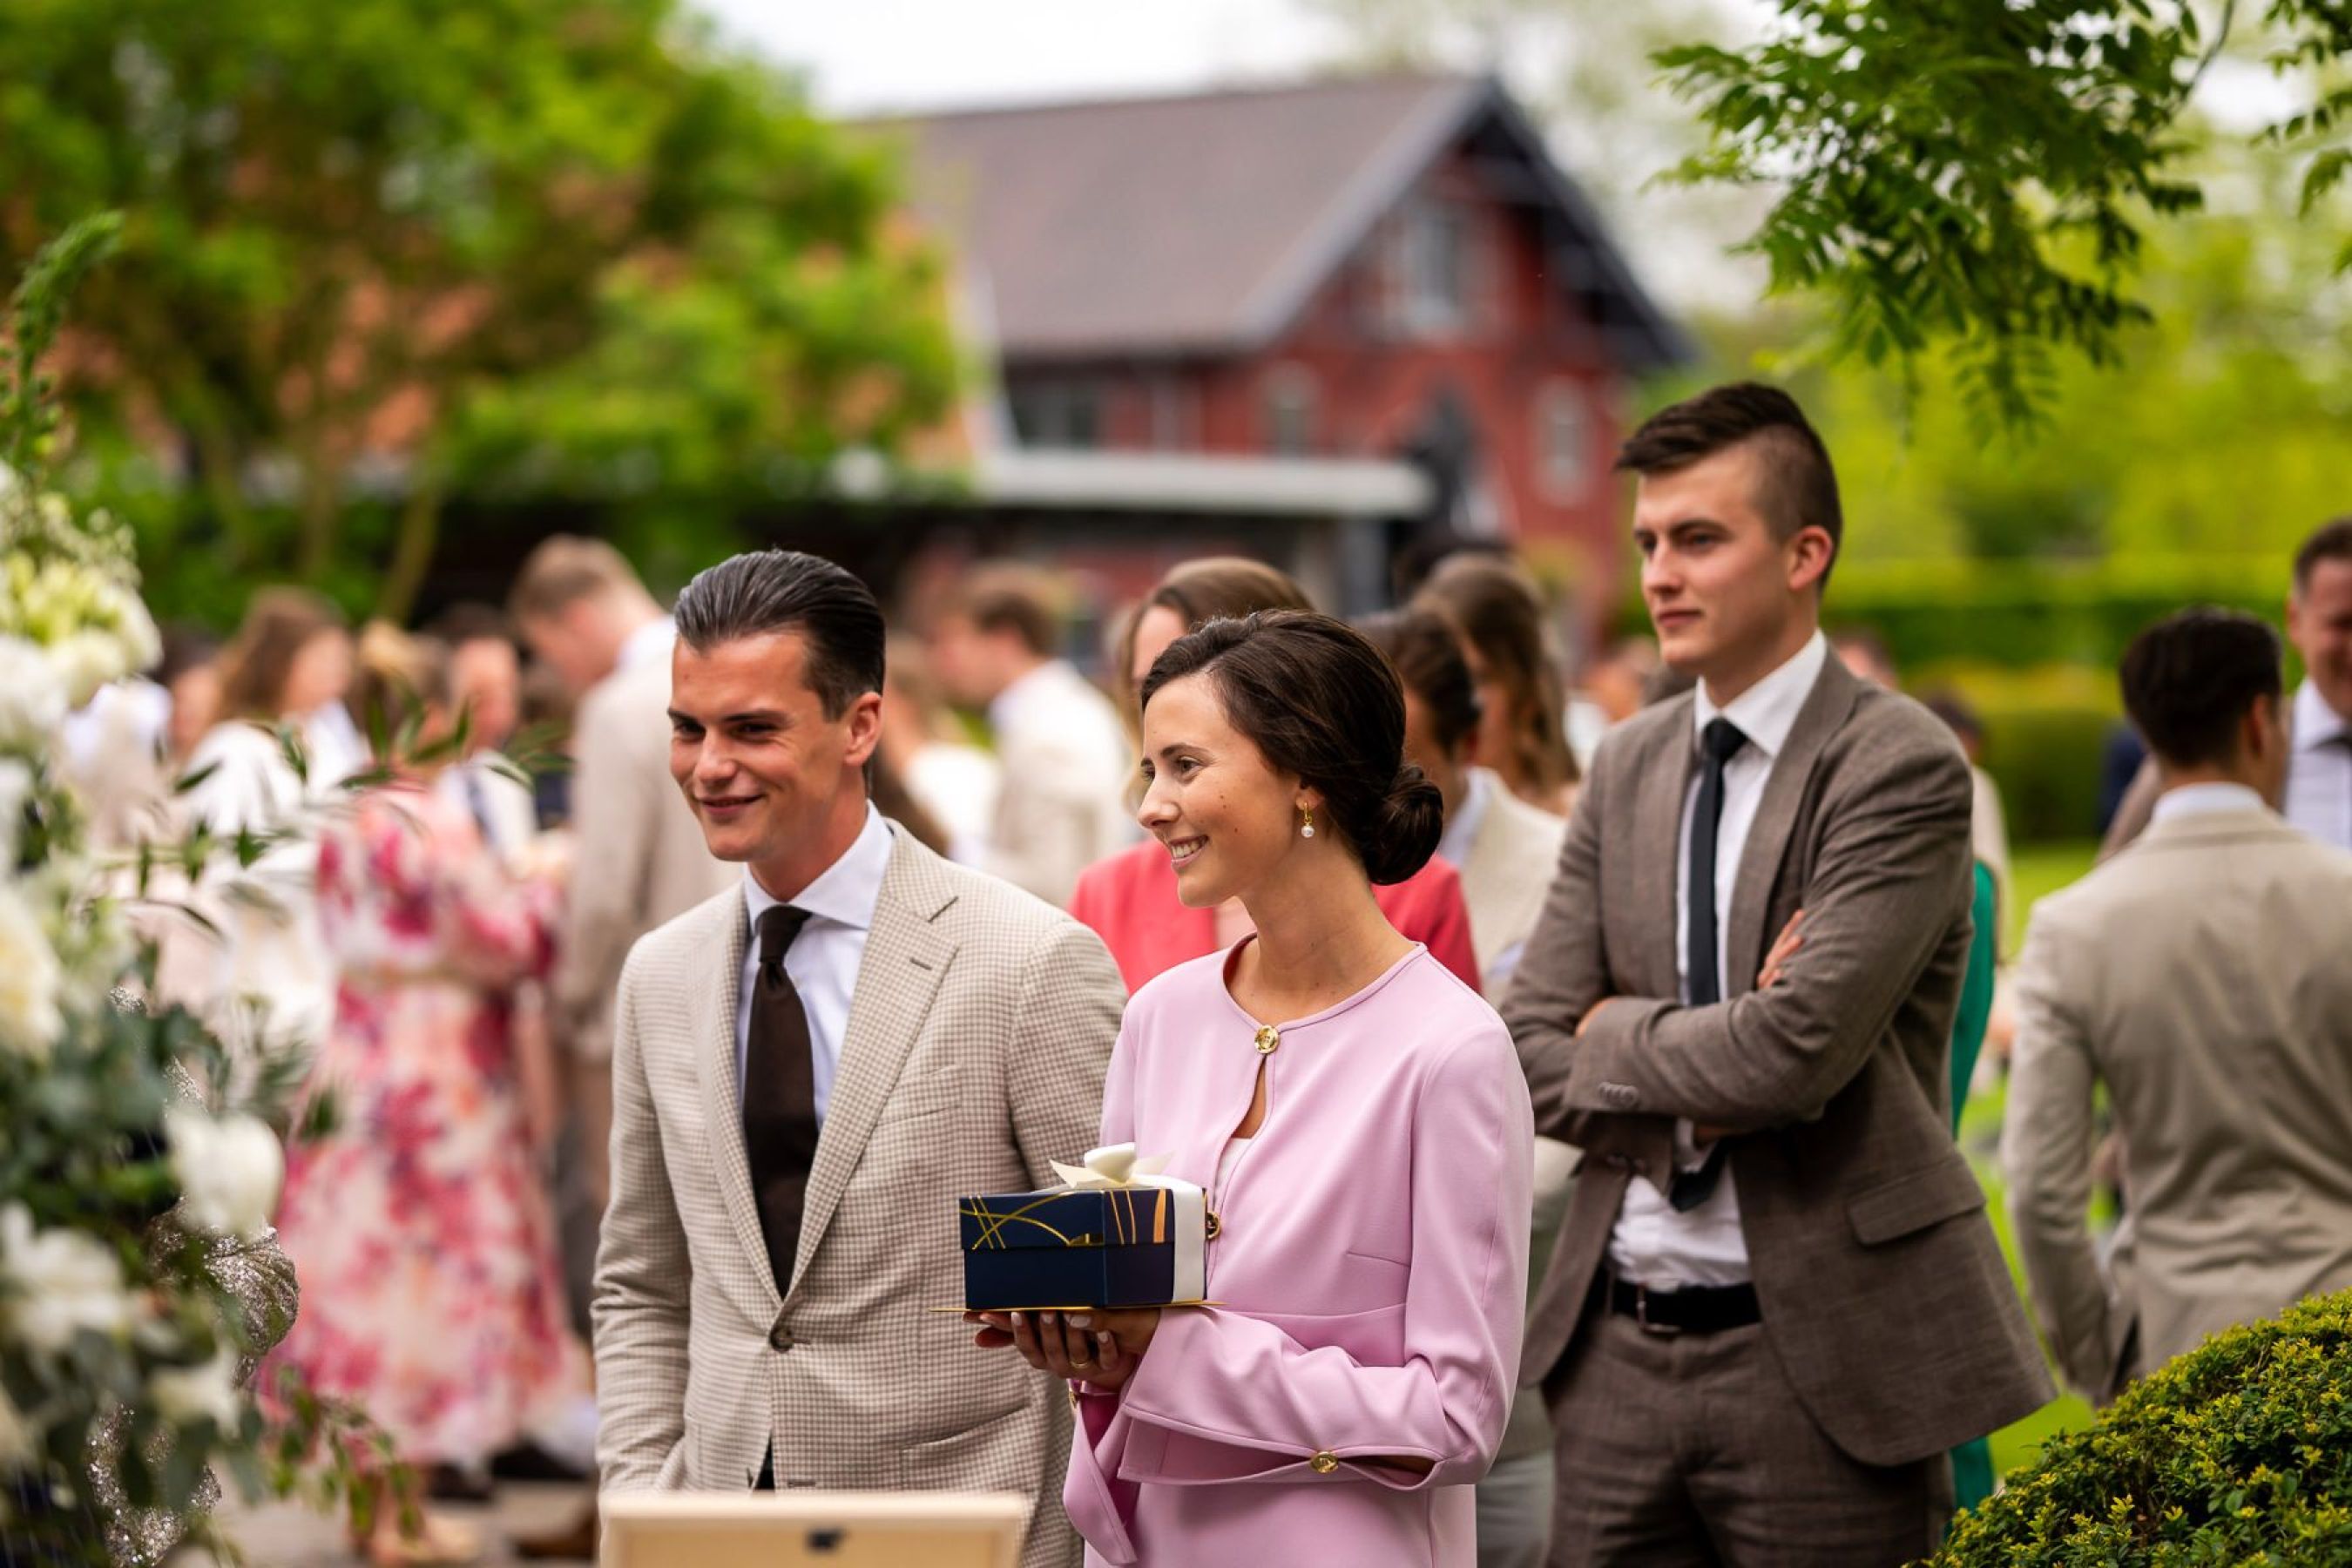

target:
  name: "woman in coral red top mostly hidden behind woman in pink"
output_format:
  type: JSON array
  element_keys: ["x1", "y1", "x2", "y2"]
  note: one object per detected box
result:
[{"x1": 1071, "y1": 555, "x2": 1479, "y2": 992}]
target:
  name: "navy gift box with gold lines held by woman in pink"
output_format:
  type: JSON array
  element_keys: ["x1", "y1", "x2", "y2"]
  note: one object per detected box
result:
[{"x1": 957, "y1": 1182, "x2": 1206, "y2": 1312}]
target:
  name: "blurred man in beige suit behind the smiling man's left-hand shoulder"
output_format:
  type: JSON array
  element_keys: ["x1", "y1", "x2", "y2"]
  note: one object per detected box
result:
[{"x1": 506, "y1": 534, "x2": 733, "y2": 1213}]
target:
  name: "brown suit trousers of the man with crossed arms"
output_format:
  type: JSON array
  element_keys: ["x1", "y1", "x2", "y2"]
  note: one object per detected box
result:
[{"x1": 1550, "y1": 1315, "x2": 1952, "y2": 1568}]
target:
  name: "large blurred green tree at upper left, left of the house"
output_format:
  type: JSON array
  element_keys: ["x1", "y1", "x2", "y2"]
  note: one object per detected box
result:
[{"x1": 0, "y1": 0, "x2": 955, "y2": 613}]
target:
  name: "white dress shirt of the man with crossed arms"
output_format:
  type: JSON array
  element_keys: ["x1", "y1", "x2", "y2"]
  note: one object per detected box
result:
[{"x1": 1609, "y1": 632, "x2": 1830, "y2": 1291}]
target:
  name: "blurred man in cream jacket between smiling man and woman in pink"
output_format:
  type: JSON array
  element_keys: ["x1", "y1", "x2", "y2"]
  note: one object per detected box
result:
[{"x1": 929, "y1": 564, "x2": 1136, "y2": 905}]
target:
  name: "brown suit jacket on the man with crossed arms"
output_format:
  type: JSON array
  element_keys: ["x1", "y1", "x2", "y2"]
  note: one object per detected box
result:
[{"x1": 1503, "y1": 659, "x2": 2051, "y2": 1464}]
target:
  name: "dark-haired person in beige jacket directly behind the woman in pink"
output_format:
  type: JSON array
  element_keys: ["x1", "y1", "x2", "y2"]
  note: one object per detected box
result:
[{"x1": 1364, "y1": 609, "x2": 1576, "y2": 1568}]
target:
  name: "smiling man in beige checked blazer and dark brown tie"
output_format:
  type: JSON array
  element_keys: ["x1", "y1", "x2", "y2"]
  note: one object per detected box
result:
[{"x1": 597, "y1": 550, "x2": 1126, "y2": 1568}]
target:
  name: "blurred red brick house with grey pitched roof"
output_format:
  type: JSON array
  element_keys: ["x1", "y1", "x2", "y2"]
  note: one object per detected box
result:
[{"x1": 901, "y1": 75, "x2": 1686, "y2": 588}]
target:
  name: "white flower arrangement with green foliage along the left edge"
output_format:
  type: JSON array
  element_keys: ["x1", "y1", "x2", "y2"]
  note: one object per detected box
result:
[{"x1": 0, "y1": 216, "x2": 365, "y2": 1564}]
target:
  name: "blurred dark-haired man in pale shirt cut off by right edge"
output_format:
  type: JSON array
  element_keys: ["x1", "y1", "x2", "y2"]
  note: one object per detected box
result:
[{"x1": 2098, "y1": 517, "x2": 2352, "y2": 861}]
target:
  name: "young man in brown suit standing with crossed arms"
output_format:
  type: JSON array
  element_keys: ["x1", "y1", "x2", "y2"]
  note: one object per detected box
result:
[{"x1": 1503, "y1": 386, "x2": 2051, "y2": 1568}]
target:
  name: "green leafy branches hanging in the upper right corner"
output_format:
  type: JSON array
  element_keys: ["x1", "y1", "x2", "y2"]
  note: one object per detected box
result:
[{"x1": 1656, "y1": 0, "x2": 2352, "y2": 428}]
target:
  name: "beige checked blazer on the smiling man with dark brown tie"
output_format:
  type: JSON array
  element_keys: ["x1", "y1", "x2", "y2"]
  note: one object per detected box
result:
[{"x1": 595, "y1": 825, "x2": 1126, "y2": 1568}]
